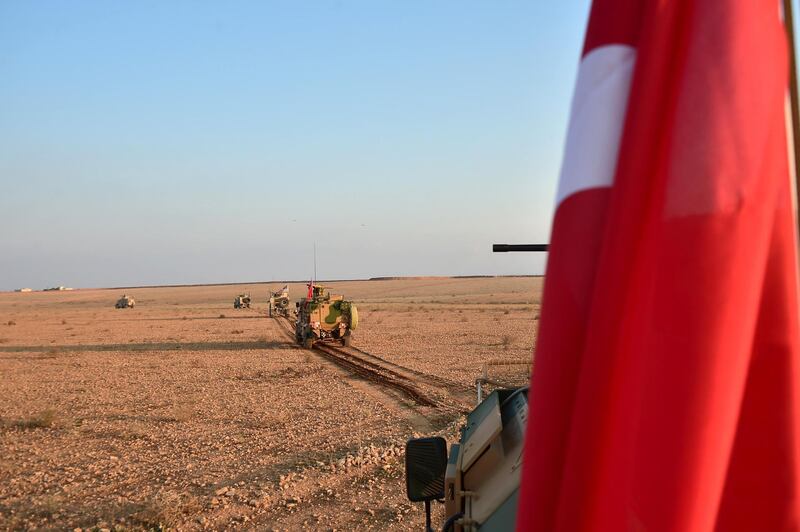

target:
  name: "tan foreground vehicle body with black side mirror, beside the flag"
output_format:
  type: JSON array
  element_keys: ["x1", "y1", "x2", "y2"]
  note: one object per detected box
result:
[{"x1": 406, "y1": 386, "x2": 528, "y2": 532}]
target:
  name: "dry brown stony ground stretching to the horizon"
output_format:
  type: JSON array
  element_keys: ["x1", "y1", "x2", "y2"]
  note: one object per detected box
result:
[{"x1": 0, "y1": 278, "x2": 542, "y2": 530}]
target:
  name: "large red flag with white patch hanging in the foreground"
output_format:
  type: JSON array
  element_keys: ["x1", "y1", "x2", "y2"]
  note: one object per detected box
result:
[{"x1": 517, "y1": 0, "x2": 800, "y2": 531}]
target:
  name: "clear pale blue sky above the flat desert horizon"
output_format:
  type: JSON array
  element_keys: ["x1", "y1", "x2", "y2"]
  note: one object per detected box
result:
[{"x1": 0, "y1": 0, "x2": 589, "y2": 290}]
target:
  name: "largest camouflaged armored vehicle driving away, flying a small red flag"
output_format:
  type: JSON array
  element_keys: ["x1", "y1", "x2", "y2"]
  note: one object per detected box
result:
[{"x1": 295, "y1": 283, "x2": 358, "y2": 349}]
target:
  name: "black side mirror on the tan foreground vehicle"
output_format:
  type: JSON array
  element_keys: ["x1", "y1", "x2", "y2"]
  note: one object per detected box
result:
[{"x1": 406, "y1": 437, "x2": 447, "y2": 503}]
